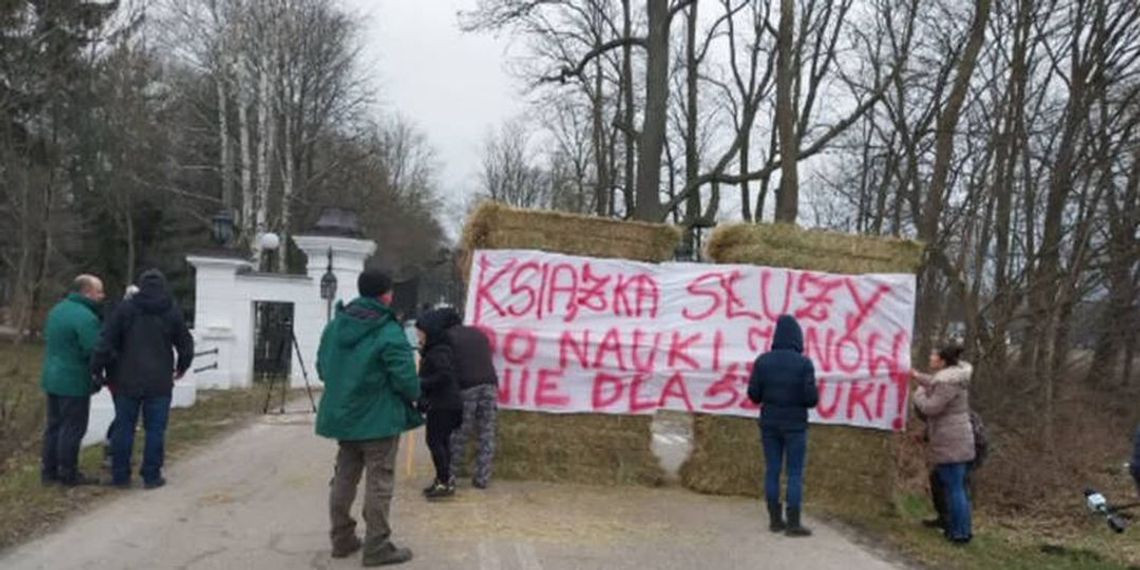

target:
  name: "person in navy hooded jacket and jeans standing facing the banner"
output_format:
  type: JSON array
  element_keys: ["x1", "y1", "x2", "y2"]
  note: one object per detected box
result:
[{"x1": 748, "y1": 315, "x2": 820, "y2": 537}]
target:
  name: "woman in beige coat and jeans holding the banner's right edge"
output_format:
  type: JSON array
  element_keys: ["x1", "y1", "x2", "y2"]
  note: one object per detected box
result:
[{"x1": 913, "y1": 347, "x2": 975, "y2": 544}]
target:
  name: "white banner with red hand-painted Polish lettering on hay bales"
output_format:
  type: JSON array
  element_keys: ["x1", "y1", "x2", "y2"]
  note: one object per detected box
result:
[{"x1": 466, "y1": 250, "x2": 914, "y2": 431}]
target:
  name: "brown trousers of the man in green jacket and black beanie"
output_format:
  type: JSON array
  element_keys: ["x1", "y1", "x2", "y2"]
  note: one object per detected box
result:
[{"x1": 328, "y1": 435, "x2": 400, "y2": 555}]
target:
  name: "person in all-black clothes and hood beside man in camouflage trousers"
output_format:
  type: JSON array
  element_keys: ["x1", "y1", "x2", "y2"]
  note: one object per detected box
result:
[{"x1": 416, "y1": 310, "x2": 463, "y2": 498}]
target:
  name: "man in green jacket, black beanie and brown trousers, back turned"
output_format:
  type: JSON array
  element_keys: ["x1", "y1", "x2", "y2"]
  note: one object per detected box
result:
[{"x1": 317, "y1": 270, "x2": 423, "y2": 567}]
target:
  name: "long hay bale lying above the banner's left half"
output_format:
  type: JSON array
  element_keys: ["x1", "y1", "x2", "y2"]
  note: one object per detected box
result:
[{"x1": 459, "y1": 202, "x2": 681, "y2": 280}]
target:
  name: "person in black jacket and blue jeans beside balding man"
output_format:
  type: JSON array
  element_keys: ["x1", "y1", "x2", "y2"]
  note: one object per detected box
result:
[{"x1": 91, "y1": 269, "x2": 194, "y2": 489}]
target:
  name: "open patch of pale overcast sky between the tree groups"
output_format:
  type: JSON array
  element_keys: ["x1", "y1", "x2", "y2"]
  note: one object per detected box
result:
[{"x1": 345, "y1": 0, "x2": 523, "y2": 214}]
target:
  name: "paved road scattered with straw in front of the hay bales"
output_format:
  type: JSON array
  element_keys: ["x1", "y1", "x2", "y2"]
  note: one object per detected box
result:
[{"x1": 0, "y1": 408, "x2": 899, "y2": 570}]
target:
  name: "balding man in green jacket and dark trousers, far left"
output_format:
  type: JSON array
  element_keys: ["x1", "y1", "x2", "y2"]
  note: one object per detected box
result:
[{"x1": 40, "y1": 275, "x2": 104, "y2": 487}]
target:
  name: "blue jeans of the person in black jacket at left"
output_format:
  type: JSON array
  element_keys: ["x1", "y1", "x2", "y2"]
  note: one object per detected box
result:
[{"x1": 111, "y1": 394, "x2": 170, "y2": 485}]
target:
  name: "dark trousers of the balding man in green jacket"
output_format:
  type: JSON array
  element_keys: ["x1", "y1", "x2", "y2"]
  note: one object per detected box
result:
[{"x1": 40, "y1": 393, "x2": 91, "y2": 482}]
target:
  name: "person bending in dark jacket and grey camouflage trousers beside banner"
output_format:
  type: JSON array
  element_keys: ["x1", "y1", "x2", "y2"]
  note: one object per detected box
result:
[{"x1": 447, "y1": 309, "x2": 498, "y2": 489}]
